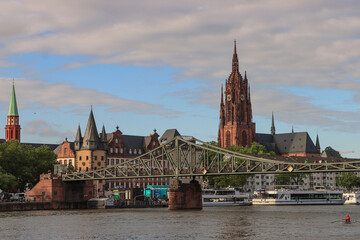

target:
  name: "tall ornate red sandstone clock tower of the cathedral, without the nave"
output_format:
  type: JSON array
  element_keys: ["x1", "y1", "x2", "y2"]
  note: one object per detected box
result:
[{"x1": 218, "y1": 41, "x2": 255, "y2": 147}]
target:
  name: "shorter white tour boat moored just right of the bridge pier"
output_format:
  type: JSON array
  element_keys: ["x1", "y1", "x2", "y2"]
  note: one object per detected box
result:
[{"x1": 202, "y1": 188, "x2": 251, "y2": 207}]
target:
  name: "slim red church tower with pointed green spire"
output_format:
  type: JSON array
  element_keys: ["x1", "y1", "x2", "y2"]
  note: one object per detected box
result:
[{"x1": 5, "y1": 83, "x2": 21, "y2": 142}]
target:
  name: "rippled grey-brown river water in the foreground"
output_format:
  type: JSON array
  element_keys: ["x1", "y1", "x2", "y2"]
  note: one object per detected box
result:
[{"x1": 0, "y1": 205, "x2": 360, "y2": 240}]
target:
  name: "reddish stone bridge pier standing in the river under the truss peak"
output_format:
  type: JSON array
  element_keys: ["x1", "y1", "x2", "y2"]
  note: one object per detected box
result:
[{"x1": 169, "y1": 179, "x2": 202, "y2": 210}]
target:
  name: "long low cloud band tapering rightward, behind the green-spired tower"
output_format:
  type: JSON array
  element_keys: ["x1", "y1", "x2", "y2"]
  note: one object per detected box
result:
[{"x1": 0, "y1": 78, "x2": 181, "y2": 118}]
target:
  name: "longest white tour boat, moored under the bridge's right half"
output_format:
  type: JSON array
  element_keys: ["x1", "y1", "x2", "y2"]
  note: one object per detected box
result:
[{"x1": 252, "y1": 190, "x2": 345, "y2": 205}]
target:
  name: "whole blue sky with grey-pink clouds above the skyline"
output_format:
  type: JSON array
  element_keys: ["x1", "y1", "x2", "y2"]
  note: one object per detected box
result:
[{"x1": 0, "y1": 0, "x2": 360, "y2": 158}]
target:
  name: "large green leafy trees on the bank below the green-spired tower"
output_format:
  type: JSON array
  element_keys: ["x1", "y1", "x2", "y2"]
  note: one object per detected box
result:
[{"x1": 0, "y1": 141, "x2": 56, "y2": 190}]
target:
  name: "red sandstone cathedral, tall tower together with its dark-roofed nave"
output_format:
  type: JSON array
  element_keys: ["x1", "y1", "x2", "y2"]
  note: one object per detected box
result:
[{"x1": 218, "y1": 42, "x2": 320, "y2": 157}]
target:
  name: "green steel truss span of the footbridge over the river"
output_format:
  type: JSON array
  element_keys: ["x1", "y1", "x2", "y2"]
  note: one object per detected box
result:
[{"x1": 62, "y1": 137, "x2": 360, "y2": 181}]
